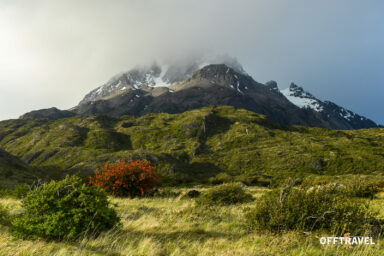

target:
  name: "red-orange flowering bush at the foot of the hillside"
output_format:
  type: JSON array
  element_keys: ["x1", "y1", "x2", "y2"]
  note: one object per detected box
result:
[{"x1": 89, "y1": 160, "x2": 161, "y2": 197}]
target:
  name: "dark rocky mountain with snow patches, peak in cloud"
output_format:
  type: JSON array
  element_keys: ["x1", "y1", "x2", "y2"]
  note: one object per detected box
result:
[{"x1": 23, "y1": 63, "x2": 378, "y2": 129}]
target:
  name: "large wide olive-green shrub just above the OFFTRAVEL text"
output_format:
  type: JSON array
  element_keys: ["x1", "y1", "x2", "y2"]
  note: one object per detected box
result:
[{"x1": 245, "y1": 186, "x2": 380, "y2": 235}]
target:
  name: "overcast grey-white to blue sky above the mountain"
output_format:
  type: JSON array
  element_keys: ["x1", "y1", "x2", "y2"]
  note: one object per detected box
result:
[{"x1": 0, "y1": 0, "x2": 384, "y2": 123}]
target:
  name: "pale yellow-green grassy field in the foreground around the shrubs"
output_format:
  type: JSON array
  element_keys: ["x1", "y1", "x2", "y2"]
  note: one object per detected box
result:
[{"x1": 0, "y1": 187, "x2": 384, "y2": 256}]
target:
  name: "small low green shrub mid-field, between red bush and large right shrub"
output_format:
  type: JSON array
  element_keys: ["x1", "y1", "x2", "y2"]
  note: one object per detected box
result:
[{"x1": 196, "y1": 183, "x2": 253, "y2": 205}]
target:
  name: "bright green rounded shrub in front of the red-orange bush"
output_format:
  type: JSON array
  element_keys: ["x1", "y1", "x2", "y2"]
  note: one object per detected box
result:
[{"x1": 11, "y1": 176, "x2": 119, "y2": 240}]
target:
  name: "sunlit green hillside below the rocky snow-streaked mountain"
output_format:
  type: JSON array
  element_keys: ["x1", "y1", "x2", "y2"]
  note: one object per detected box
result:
[{"x1": 0, "y1": 106, "x2": 384, "y2": 183}]
